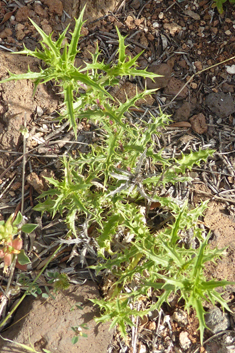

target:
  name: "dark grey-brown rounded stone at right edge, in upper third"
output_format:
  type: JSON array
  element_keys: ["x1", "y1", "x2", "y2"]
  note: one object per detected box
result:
[{"x1": 205, "y1": 92, "x2": 235, "y2": 119}]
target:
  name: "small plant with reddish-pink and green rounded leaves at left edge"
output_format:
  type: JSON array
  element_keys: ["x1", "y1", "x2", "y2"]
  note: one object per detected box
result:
[{"x1": 0, "y1": 212, "x2": 37, "y2": 272}]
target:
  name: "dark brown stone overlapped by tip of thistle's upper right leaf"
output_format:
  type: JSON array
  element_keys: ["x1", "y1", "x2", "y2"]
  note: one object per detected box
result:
[{"x1": 146, "y1": 64, "x2": 172, "y2": 89}]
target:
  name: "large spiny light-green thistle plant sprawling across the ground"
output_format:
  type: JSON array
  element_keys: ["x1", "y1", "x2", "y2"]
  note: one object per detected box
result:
[{"x1": 1, "y1": 5, "x2": 233, "y2": 341}]
